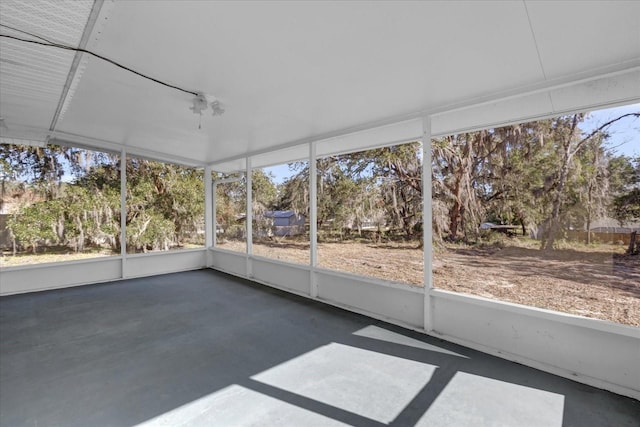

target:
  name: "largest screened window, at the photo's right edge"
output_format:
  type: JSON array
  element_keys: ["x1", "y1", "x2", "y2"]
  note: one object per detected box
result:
[{"x1": 432, "y1": 105, "x2": 640, "y2": 326}]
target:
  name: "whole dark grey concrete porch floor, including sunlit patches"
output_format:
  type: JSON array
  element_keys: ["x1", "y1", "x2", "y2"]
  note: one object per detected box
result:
[{"x1": 0, "y1": 270, "x2": 640, "y2": 427}]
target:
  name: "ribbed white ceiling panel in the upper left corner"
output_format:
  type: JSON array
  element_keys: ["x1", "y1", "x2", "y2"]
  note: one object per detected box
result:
[{"x1": 0, "y1": 0, "x2": 93, "y2": 140}]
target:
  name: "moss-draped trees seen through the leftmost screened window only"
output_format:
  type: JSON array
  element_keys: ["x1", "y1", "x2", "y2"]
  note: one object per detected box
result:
[{"x1": 0, "y1": 144, "x2": 120, "y2": 254}]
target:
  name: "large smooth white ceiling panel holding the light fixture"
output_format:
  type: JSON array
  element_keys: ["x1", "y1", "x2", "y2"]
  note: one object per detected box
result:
[{"x1": 59, "y1": 1, "x2": 542, "y2": 162}]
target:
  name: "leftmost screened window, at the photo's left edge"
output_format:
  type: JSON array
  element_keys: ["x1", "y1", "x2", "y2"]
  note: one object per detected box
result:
[{"x1": 0, "y1": 144, "x2": 120, "y2": 267}]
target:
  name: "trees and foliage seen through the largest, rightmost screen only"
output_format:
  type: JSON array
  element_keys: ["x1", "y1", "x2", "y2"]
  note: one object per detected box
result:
[{"x1": 432, "y1": 114, "x2": 635, "y2": 247}]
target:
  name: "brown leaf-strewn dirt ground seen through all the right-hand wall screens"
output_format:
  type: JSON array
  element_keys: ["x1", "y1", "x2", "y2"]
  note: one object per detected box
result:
[{"x1": 221, "y1": 242, "x2": 640, "y2": 326}]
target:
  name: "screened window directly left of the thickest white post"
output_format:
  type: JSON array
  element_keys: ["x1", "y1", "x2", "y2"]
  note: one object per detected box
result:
[{"x1": 317, "y1": 142, "x2": 424, "y2": 286}]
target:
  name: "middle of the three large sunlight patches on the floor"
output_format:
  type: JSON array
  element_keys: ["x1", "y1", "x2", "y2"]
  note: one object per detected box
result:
[{"x1": 251, "y1": 343, "x2": 437, "y2": 423}]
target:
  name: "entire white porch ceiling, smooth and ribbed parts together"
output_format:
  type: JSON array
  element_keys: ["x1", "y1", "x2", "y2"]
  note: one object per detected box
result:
[{"x1": 0, "y1": 0, "x2": 640, "y2": 164}]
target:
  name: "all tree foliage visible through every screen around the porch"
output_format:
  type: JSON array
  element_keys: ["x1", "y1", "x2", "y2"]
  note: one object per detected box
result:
[{"x1": 0, "y1": 110, "x2": 640, "y2": 258}]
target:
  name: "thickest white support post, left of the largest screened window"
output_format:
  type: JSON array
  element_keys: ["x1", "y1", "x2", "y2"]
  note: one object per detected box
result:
[{"x1": 422, "y1": 116, "x2": 433, "y2": 333}]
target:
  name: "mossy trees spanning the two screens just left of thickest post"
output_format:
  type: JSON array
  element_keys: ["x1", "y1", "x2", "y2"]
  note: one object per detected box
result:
[{"x1": 277, "y1": 143, "x2": 422, "y2": 238}]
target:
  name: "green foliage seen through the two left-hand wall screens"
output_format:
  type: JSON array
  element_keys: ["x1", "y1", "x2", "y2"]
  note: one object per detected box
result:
[{"x1": 0, "y1": 144, "x2": 204, "y2": 258}]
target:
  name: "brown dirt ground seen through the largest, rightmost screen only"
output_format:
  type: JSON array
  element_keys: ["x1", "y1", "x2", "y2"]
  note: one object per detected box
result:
[{"x1": 433, "y1": 247, "x2": 640, "y2": 326}]
